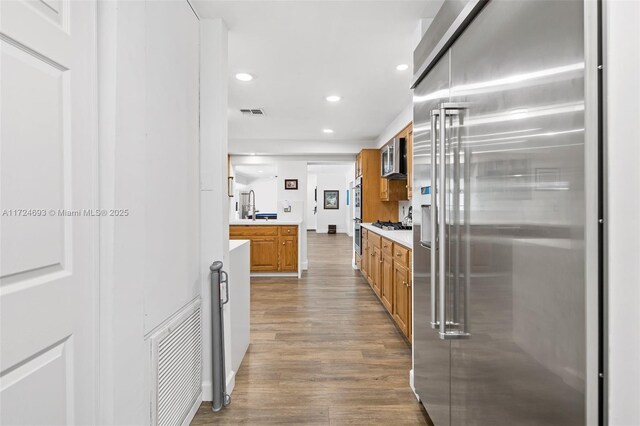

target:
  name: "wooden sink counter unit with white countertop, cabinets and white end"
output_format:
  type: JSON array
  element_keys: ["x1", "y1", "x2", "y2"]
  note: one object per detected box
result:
[{"x1": 229, "y1": 219, "x2": 302, "y2": 278}]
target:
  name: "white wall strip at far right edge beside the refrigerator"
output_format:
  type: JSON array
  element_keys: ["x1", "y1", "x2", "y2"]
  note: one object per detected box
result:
[{"x1": 604, "y1": 1, "x2": 640, "y2": 426}]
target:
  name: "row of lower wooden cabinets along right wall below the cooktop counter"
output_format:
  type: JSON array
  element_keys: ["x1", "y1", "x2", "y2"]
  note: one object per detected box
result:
[{"x1": 356, "y1": 231, "x2": 412, "y2": 342}]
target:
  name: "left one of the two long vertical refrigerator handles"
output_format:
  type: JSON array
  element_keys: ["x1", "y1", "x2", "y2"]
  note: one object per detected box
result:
[{"x1": 430, "y1": 109, "x2": 440, "y2": 330}]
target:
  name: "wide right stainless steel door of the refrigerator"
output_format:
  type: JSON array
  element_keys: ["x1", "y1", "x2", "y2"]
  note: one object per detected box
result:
[{"x1": 451, "y1": 1, "x2": 595, "y2": 425}]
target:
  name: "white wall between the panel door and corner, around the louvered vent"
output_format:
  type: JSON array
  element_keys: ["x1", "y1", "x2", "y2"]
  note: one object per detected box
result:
[{"x1": 98, "y1": 1, "x2": 200, "y2": 424}]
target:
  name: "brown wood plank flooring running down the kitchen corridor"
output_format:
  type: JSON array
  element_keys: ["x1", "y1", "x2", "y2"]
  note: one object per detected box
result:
[{"x1": 192, "y1": 232, "x2": 427, "y2": 425}]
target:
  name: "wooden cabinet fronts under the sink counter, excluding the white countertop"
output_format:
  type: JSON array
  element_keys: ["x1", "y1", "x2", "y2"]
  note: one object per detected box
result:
[{"x1": 229, "y1": 225, "x2": 298, "y2": 272}]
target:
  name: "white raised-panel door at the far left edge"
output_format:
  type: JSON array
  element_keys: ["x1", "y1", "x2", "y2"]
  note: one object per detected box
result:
[{"x1": 0, "y1": 0, "x2": 98, "y2": 425}]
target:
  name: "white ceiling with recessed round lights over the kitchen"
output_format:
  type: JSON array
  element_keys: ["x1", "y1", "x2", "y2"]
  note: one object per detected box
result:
[{"x1": 194, "y1": 0, "x2": 442, "y2": 154}]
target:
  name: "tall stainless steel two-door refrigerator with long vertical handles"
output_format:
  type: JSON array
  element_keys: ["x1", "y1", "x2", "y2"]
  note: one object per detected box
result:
[{"x1": 413, "y1": 0, "x2": 598, "y2": 426}]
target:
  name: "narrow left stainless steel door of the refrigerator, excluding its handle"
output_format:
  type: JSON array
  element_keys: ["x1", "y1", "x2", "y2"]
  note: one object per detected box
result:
[{"x1": 412, "y1": 53, "x2": 451, "y2": 425}]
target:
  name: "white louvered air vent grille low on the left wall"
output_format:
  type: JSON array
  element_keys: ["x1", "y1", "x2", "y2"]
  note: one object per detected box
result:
[{"x1": 151, "y1": 301, "x2": 202, "y2": 426}]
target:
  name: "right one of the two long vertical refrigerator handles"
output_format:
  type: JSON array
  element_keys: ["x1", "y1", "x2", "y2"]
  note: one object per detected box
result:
[{"x1": 437, "y1": 103, "x2": 470, "y2": 340}]
